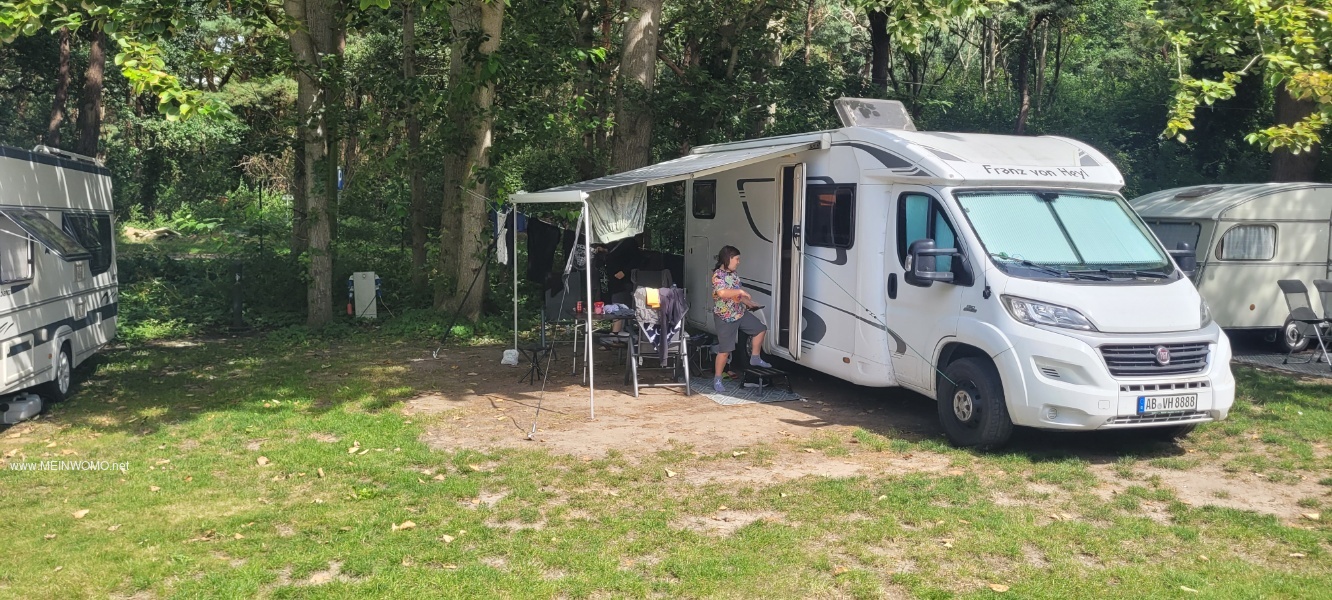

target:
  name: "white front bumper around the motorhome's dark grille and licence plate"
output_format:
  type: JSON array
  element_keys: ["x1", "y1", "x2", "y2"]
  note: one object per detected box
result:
[{"x1": 1000, "y1": 324, "x2": 1235, "y2": 431}]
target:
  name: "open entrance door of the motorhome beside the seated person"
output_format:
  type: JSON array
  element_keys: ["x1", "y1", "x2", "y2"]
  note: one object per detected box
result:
[{"x1": 770, "y1": 163, "x2": 805, "y2": 360}]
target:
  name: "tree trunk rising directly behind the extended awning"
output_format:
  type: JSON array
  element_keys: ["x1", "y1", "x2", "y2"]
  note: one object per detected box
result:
[{"x1": 610, "y1": 0, "x2": 662, "y2": 173}]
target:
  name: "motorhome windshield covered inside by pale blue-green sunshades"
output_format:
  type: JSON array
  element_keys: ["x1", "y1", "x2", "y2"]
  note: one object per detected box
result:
[{"x1": 956, "y1": 191, "x2": 1173, "y2": 279}]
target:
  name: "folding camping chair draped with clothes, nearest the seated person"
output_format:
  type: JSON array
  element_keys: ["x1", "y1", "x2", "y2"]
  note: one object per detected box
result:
[{"x1": 625, "y1": 285, "x2": 693, "y2": 397}]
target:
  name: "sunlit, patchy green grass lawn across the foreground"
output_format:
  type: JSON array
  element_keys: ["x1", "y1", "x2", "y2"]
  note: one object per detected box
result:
[{"x1": 0, "y1": 333, "x2": 1332, "y2": 599}]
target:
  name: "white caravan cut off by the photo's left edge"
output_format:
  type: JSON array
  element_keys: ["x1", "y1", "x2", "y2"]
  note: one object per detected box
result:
[{"x1": 0, "y1": 147, "x2": 117, "y2": 423}]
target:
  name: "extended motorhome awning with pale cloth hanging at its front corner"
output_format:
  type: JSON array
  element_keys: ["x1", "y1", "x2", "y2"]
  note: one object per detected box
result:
[{"x1": 511, "y1": 141, "x2": 819, "y2": 243}]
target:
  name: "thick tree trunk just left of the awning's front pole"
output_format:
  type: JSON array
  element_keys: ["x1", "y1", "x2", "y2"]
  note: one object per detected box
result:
[{"x1": 436, "y1": 0, "x2": 503, "y2": 320}]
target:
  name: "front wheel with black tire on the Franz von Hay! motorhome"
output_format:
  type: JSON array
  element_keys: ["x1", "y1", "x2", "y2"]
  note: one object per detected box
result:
[{"x1": 938, "y1": 359, "x2": 1012, "y2": 451}]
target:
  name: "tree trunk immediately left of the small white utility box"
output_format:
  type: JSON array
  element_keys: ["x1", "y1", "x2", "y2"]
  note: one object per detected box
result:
[{"x1": 282, "y1": 0, "x2": 340, "y2": 328}]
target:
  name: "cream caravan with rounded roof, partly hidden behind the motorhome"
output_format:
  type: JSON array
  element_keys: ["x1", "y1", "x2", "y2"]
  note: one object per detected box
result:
[{"x1": 1131, "y1": 183, "x2": 1332, "y2": 351}]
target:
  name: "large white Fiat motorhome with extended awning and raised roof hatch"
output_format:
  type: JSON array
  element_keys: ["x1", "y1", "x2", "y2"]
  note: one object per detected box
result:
[{"x1": 523, "y1": 99, "x2": 1235, "y2": 448}]
